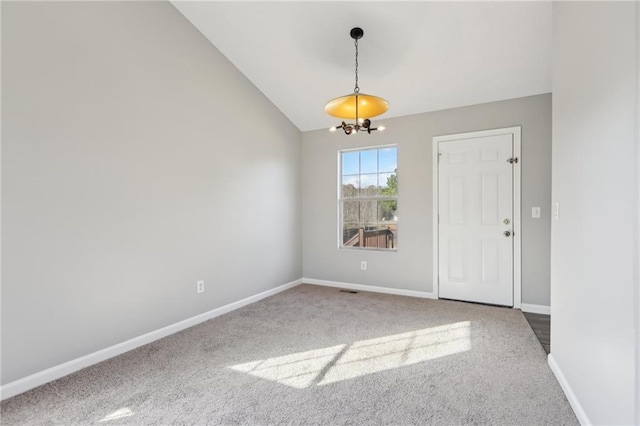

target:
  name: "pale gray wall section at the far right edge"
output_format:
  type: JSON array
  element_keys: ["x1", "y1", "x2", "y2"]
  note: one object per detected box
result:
[{"x1": 551, "y1": 2, "x2": 640, "y2": 425}]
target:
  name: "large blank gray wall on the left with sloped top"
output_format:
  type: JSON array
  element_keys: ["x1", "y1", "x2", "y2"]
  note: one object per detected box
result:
[{"x1": 2, "y1": 2, "x2": 302, "y2": 384}]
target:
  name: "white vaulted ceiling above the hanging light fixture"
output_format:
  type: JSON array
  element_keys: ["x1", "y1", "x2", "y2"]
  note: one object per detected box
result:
[{"x1": 172, "y1": 1, "x2": 551, "y2": 131}]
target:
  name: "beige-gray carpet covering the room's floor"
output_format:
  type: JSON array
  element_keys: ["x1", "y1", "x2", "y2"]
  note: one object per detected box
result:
[{"x1": 1, "y1": 285, "x2": 578, "y2": 425}]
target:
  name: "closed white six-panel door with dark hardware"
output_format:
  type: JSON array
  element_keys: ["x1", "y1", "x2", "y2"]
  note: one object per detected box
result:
[{"x1": 438, "y1": 134, "x2": 514, "y2": 306}]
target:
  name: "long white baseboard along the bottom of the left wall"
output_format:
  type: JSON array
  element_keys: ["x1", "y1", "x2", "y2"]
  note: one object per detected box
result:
[{"x1": 0, "y1": 279, "x2": 302, "y2": 400}]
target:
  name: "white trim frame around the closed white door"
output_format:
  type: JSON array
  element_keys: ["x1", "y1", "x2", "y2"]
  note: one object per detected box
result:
[{"x1": 431, "y1": 126, "x2": 522, "y2": 309}]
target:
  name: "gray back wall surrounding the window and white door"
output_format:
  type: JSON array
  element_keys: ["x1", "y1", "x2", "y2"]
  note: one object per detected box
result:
[{"x1": 302, "y1": 94, "x2": 551, "y2": 306}]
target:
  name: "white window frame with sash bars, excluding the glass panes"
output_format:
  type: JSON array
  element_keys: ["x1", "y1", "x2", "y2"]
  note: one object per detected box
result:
[{"x1": 337, "y1": 144, "x2": 400, "y2": 253}]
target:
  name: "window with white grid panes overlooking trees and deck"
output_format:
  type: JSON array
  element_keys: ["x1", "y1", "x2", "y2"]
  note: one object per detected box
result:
[{"x1": 339, "y1": 146, "x2": 398, "y2": 249}]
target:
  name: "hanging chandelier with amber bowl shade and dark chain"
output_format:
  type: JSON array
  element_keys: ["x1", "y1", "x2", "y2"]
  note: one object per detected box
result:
[{"x1": 324, "y1": 27, "x2": 389, "y2": 135}]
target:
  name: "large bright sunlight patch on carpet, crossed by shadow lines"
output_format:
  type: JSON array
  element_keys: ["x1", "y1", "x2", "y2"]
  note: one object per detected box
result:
[{"x1": 229, "y1": 321, "x2": 471, "y2": 389}]
